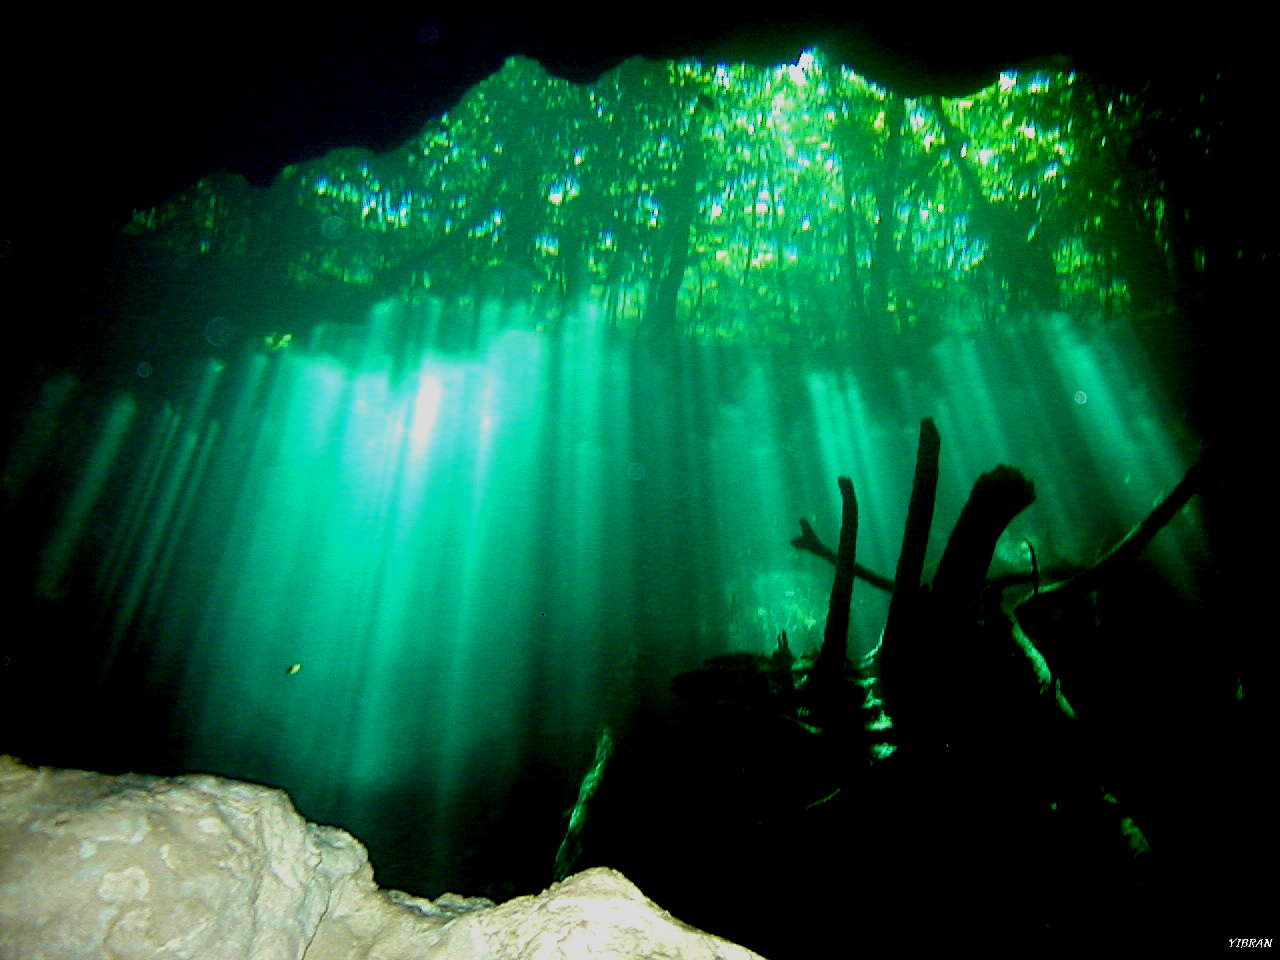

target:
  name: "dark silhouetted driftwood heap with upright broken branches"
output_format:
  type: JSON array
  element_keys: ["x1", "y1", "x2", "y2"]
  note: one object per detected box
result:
[{"x1": 558, "y1": 420, "x2": 1203, "y2": 960}]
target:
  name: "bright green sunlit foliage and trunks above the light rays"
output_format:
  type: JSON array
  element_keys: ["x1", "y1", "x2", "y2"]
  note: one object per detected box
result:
[{"x1": 124, "y1": 51, "x2": 1169, "y2": 346}]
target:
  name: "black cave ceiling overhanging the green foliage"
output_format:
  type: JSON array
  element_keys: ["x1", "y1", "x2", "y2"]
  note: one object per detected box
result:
[{"x1": 3, "y1": 3, "x2": 1225, "y2": 227}]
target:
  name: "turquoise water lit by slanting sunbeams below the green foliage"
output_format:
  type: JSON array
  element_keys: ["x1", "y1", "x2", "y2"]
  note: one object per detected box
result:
[{"x1": 3, "y1": 330, "x2": 1204, "y2": 896}]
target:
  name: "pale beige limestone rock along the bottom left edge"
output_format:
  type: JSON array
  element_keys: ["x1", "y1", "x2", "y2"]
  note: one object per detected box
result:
[{"x1": 0, "y1": 758, "x2": 756, "y2": 960}]
